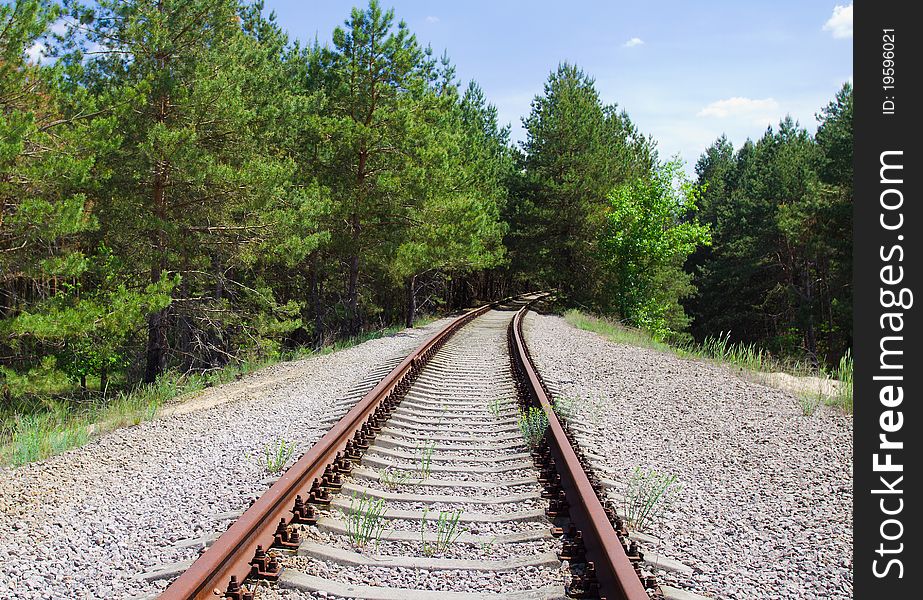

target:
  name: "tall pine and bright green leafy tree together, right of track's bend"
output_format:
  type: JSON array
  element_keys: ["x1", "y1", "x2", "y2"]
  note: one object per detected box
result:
[{"x1": 506, "y1": 64, "x2": 709, "y2": 337}]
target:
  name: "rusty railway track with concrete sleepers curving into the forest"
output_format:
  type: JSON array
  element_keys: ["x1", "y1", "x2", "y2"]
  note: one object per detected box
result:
[{"x1": 160, "y1": 301, "x2": 670, "y2": 600}]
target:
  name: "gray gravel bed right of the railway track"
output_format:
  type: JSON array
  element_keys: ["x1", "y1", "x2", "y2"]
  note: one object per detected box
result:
[{"x1": 525, "y1": 314, "x2": 852, "y2": 600}]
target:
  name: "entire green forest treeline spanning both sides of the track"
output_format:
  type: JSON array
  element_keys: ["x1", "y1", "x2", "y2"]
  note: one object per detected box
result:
[{"x1": 0, "y1": 0, "x2": 852, "y2": 403}]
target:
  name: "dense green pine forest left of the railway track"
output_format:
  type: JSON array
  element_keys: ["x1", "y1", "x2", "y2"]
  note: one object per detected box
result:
[{"x1": 0, "y1": 0, "x2": 513, "y2": 400}]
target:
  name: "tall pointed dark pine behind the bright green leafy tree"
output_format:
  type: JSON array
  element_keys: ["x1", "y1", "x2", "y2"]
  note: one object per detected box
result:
[{"x1": 506, "y1": 63, "x2": 654, "y2": 304}]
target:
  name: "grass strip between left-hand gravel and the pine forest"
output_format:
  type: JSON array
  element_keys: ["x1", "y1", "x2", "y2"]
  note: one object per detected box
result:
[{"x1": 0, "y1": 316, "x2": 436, "y2": 467}]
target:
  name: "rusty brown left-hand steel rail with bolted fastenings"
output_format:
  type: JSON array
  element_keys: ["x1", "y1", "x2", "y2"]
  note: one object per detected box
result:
[{"x1": 159, "y1": 303, "x2": 497, "y2": 600}]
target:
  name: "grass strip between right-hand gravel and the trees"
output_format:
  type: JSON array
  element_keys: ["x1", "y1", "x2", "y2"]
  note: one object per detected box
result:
[{"x1": 564, "y1": 310, "x2": 853, "y2": 415}]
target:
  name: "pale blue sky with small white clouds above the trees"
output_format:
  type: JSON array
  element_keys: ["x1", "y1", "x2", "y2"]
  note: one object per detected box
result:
[{"x1": 266, "y1": 0, "x2": 852, "y2": 172}]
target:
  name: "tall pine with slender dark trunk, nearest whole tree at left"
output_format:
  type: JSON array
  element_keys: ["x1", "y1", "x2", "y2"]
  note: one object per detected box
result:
[{"x1": 74, "y1": 0, "x2": 285, "y2": 381}]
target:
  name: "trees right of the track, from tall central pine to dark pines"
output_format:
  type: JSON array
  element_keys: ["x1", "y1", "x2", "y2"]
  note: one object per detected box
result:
[{"x1": 506, "y1": 65, "x2": 853, "y2": 368}]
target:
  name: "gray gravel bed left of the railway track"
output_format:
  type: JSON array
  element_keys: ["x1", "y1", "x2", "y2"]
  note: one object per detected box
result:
[{"x1": 0, "y1": 320, "x2": 447, "y2": 600}]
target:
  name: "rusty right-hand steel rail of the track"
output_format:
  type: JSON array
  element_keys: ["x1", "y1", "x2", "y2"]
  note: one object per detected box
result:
[{"x1": 512, "y1": 302, "x2": 649, "y2": 600}]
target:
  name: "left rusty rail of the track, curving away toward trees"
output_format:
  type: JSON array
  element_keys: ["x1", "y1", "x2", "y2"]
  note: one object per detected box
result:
[{"x1": 160, "y1": 304, "x2": 494, "y2": 600}]
